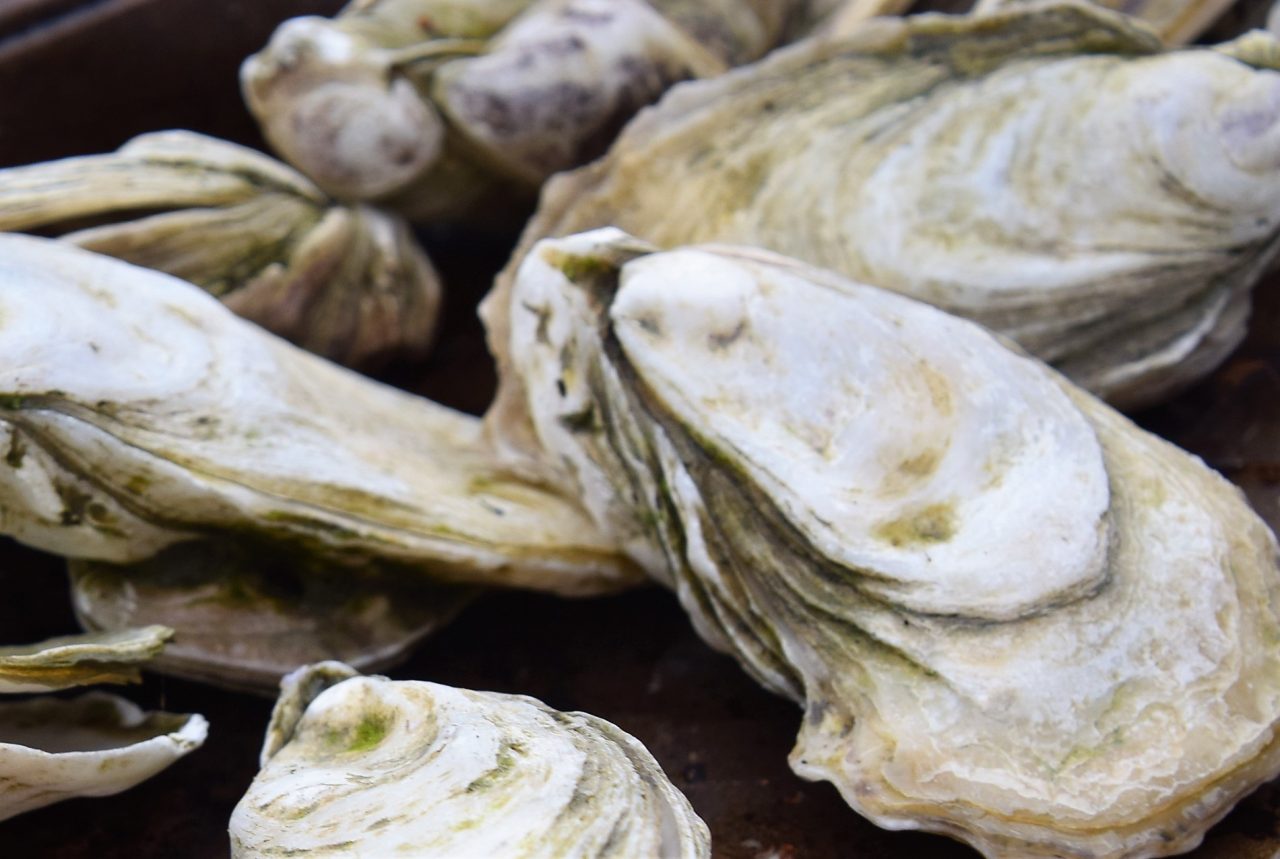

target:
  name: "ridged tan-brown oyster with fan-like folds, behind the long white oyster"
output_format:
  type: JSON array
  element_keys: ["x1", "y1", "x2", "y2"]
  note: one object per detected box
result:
[{"x1": 0, "y1": 132, "x2": 440, "y2": 367}]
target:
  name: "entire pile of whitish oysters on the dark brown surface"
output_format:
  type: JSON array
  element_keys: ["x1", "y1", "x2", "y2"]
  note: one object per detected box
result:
[{"x1": 0, "y1": 0, "x2": 1280, "y2": 859}]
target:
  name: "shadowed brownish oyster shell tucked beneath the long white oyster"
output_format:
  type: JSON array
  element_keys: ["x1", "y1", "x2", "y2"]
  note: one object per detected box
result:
[{"x1": 67, "y1": 539, "x2": 476, "y2": 694}]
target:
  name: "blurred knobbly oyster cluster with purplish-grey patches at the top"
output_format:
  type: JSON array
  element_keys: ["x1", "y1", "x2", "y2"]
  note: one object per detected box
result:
[{"x1": 241, "y1": 0, "x2": 808, "y2": 223}]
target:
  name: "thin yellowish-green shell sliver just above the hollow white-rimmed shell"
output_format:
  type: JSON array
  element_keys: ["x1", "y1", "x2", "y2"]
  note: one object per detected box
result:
[{"x1": 0, "y1": 625, "x2": 173, "y2": 694}]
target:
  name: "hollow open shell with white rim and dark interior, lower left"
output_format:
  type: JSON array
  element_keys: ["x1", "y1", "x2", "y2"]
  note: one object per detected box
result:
[{"x1": 0, "y1": 693, "x2": 209, "y2": 819}]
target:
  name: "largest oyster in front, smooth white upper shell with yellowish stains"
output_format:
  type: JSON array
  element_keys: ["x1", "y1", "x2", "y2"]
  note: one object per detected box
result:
[{"x1": 483, "y1": 230, "x2": 1280, "y2": 859}]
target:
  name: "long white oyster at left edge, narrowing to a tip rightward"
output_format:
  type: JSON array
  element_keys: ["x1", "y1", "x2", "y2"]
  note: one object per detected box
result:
[{"x1": 0, "y1": 236, "x2": 637, "y2": 594}]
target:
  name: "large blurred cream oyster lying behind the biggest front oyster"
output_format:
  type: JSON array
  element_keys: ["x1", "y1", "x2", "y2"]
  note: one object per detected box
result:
[{"x1": 499, "y1": 5, "x2": 1280, "y2": 406}]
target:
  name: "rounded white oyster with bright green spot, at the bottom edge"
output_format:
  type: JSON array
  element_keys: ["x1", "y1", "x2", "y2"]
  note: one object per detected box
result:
[{"x1": 230, "y1": 662, "x2": 710, "y2": 859}]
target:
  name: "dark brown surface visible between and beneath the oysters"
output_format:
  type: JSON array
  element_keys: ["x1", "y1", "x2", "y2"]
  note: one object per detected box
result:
[{"x1": 0, "y1": 0, "x2": 1280, "y2": 859}]
